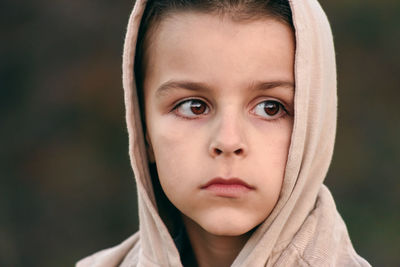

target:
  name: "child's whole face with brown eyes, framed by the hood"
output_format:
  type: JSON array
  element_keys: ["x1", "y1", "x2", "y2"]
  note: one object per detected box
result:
[{"x1": 144, "y1": 13, "x2": 295, "y2": 236}]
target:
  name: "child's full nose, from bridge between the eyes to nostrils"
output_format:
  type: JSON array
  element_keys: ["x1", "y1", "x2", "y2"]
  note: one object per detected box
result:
[{"x1": 210, "y1": 105, "x2": 247, "y2": 156}]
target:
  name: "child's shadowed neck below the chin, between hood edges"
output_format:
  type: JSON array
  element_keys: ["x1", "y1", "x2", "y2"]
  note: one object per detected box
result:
[{"x1": 182, "y1": 215, "x2": 251, "y2": 267}]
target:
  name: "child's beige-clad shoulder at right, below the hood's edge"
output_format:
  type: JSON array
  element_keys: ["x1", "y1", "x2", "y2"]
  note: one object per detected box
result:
[{"x1": 277, "y1": 190, "x2": 371, "y2": 267}]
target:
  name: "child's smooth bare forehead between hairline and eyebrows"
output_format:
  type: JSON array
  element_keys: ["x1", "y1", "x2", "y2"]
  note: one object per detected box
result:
[{"x1": 145, "y1": 13, "x2": 295, "y2": 93}]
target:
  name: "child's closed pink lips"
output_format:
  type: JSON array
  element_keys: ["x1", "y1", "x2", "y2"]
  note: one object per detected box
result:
[{"x1": 200, "y1": 177, "x2": 255, "y2": 198}]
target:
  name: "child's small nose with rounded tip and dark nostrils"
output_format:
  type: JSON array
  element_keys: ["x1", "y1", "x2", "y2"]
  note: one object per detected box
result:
[{"x1": 209, "y1": 113, "x2": 248, "y2": 158}]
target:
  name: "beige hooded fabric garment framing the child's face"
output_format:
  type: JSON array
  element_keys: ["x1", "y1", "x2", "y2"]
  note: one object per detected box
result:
[{"x1": 77, "y1": 0, "x2": 370, "y2": 267}]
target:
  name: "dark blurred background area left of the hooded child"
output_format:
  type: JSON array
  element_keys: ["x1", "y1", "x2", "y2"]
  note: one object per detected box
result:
[{"x1": 0, "y1": 0, "x2": 137, "y2": 267}]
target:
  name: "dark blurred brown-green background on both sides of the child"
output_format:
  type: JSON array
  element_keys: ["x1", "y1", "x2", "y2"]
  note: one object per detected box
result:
[{"x1": 0, "y1": 0, "x2": 400, "y2": 267}]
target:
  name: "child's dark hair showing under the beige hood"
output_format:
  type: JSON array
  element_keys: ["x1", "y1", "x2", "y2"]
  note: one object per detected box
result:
[{"x1": 134, "y1": 0, "x2": 294, "y2": 106}]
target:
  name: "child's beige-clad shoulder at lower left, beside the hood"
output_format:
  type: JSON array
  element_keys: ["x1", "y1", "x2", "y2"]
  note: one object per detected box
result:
[{"x1": 76, "y1": 232, "x2": 140, "y2": 267}]
